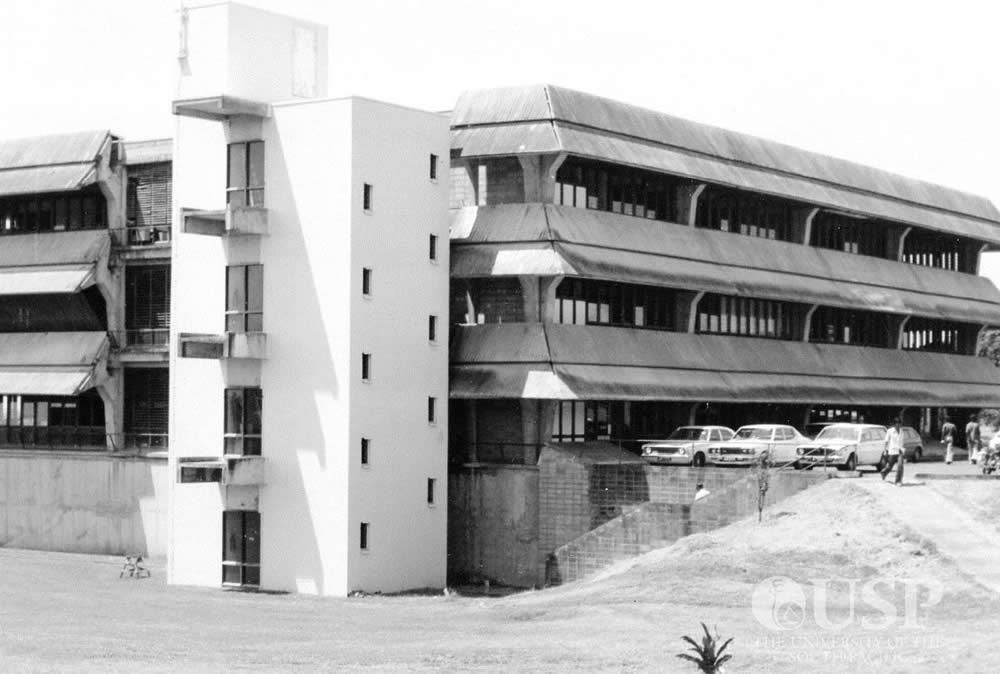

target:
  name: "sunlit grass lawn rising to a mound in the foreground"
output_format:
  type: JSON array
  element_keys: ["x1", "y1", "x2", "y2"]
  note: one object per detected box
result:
[{"x1": 0, "y1": 480, "x2": 1000, "y2": 672}]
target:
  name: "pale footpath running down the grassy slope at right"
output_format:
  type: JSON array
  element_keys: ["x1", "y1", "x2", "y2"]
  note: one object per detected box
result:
[{"x1": 855, "y1": 478, "x2": 1000, "y2": 594}]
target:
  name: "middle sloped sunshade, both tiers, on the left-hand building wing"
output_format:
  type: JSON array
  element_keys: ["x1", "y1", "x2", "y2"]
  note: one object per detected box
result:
[{"x1": 0, "y1": 230, "x2": 111, "y2": 295}]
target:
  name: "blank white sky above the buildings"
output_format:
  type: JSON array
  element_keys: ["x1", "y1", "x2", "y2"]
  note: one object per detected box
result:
[{"x1": 0, "y1": 0, "x2": 1000, "y2": 280}]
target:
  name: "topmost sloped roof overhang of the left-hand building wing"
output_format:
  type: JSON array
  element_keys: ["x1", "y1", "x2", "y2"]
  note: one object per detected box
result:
[{"x1": 0, "y1": 131, "x2": 111, "y2": 196}]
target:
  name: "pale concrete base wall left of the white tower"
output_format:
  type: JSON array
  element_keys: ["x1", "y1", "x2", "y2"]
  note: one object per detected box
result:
[{"x1": 0, "y1": 451, "x2": 169, "y2": 557}]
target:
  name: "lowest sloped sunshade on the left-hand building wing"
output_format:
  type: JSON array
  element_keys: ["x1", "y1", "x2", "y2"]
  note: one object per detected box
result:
[{"x1": 0, "y1": 332, "x2": 108, "y2": 396}]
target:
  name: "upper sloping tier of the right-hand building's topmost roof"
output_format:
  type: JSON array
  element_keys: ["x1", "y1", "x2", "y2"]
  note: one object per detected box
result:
[{"x1": 452, "y1": 85, "x2": 1000, "y2": 224}]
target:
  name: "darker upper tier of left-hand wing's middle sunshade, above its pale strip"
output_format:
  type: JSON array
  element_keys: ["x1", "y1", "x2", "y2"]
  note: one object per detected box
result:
[{"x1": 0, "y1": 229, "x2": 111, "y2": 268}]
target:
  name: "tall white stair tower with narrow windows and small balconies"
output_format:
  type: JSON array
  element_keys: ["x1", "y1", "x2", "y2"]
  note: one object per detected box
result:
[{"x1": 168, "y1": 3, "x2": 448, "y2": 595}]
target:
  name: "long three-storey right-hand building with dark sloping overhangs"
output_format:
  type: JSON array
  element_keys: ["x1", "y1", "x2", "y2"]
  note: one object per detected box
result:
[{"x1": 449, "y1": 86, "x2": 1000, "y2": 584}]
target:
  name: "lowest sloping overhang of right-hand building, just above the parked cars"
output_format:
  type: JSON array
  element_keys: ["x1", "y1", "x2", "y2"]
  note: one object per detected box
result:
[{"x1": 451, "y1": 324, "x2": 1000, "y2": 407}]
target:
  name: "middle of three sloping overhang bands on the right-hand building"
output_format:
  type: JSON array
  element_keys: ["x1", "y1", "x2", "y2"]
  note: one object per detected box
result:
[{"x1": 451, "y1": 204, "x2": 1000, "y2": 323}]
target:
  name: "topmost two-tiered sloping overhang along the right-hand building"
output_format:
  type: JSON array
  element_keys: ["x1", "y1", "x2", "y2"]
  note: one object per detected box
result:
[{"x1": 451, "y1": 85, "x2": 1000, "y2": 244}]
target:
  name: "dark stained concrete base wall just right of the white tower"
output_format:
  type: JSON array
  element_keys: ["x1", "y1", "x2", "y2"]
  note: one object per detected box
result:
[{"x1": 448, "y1": 466, "x2": 539, "y2": 587}]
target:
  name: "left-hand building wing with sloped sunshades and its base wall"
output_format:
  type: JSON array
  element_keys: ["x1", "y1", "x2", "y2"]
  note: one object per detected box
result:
[{"x1": 0, "y1": 131, "x2": 171, "y2": 554}]
